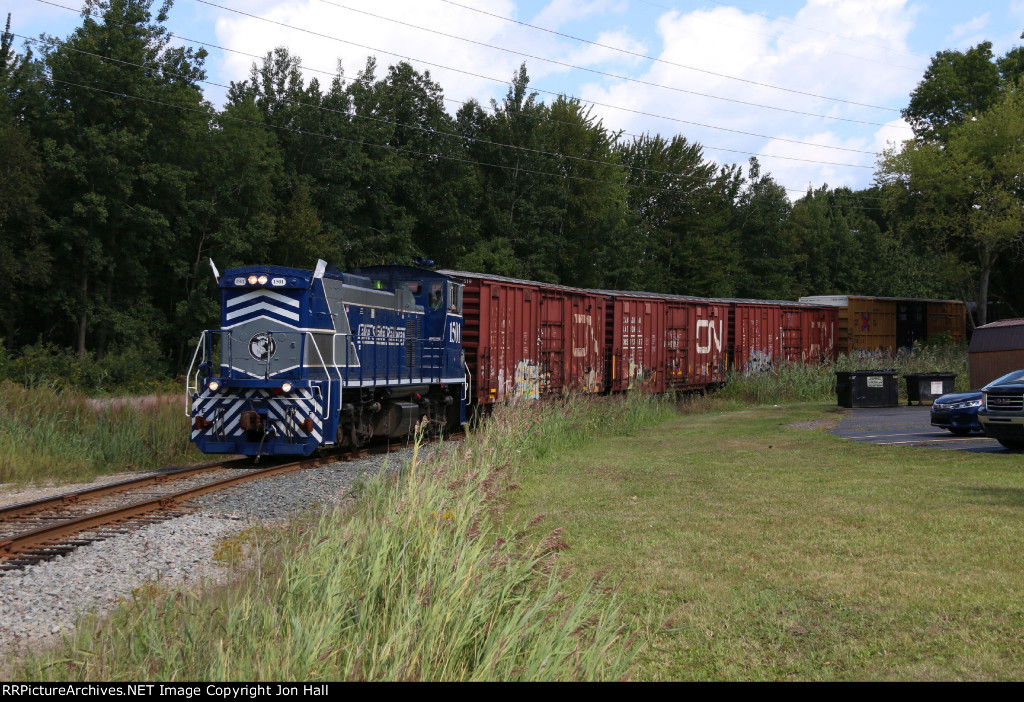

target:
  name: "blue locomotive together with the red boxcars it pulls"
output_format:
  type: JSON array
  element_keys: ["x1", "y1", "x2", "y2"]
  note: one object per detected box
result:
[{"x1": 185, "y1": 261, "x2": 962, "y2": 456}]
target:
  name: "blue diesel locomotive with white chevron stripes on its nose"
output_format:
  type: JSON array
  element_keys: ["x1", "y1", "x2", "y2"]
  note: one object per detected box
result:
[{"x1": 185, "y1": 261, "x2": 470, "y2": 458}]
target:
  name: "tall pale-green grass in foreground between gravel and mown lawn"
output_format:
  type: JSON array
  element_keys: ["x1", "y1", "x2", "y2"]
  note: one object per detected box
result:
[{"x1": 18, "y1": 396, "x2": 673, "y2": 681}]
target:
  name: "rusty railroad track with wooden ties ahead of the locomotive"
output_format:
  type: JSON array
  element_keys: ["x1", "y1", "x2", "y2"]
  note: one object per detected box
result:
[{"x1": 0, "y1": 435, "x2": 462, "y2": 575}]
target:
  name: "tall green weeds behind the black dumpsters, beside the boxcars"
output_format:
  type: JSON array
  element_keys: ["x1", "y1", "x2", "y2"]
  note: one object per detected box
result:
[{"x1": 720, "y1": 344, "x2": 970, "y2": 404}]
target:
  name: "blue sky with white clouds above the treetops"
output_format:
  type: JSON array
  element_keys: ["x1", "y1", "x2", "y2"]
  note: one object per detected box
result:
[{"x1": 0, "y1": 0, "x2": 1024, "y2": 198}]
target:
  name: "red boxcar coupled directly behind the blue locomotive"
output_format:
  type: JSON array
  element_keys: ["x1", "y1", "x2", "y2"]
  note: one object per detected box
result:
[{"x1": 440, "y1": 270, "x2": 605, "y2": 404}]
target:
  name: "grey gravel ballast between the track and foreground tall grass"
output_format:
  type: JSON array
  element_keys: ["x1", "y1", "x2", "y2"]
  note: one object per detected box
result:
[{"x1": 0, "y1": 449, "x2": 423, "y2": 655}]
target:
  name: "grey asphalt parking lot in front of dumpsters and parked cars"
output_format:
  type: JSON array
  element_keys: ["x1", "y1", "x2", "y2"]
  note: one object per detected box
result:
[{"x1": 831, "y1": 405, "x2": 1012, "y2": 453}]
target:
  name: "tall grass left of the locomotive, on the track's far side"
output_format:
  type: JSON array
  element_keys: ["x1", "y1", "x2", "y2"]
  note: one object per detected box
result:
[{"x1": 0, "y1": 381, "x2": 200, "y2": 484}]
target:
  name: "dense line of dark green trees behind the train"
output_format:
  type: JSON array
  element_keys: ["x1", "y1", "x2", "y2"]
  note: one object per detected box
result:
[{"x1": 0, "y1": 0, "x2": 1024, "y2": 384}]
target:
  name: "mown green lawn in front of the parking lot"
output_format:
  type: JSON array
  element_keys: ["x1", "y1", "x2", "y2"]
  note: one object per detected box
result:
[{"x1": 513, "y1": 404, "x2": 1024, "y2": 679}]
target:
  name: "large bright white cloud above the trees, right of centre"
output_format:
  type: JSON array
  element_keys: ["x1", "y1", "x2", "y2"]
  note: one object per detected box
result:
[{"x1": 584, "y1": 0, "x2": 923, "y2": 196}]
